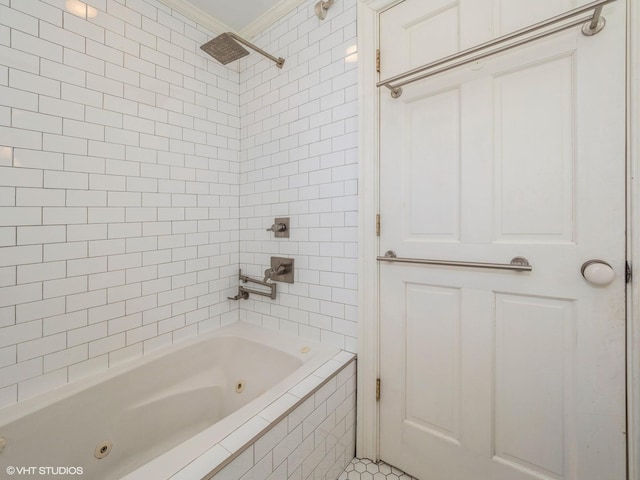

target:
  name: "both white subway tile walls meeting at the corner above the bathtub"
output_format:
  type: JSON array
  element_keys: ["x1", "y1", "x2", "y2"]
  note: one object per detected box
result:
[{"x1": 0, "y1": 0, "x2": 357, "y2": 406}]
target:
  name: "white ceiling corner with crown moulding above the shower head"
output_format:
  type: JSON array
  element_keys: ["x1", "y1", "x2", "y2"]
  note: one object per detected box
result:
[{"x1": 160, "y1": 0, "x2": 305, "y2": 38}]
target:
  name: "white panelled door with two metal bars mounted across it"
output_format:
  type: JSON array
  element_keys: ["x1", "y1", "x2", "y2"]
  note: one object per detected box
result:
[{"x1": 379, "y1": 0, "x2": 626, "y2": 480}]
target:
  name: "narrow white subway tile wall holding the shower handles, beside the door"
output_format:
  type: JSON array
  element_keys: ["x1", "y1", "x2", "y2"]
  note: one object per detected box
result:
[{"x1": 240, "y1": 0, "x2": 358, "y2": 352}]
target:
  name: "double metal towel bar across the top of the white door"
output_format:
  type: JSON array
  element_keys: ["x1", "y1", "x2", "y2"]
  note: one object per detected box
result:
[{"x1": 376, "y1": 0, "x2": 616, "y2": 98}]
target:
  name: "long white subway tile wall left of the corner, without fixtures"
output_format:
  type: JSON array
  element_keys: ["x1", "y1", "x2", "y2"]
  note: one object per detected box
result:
[{"x1": 0, "y1": 0, "x2": 240, "y2": 406}]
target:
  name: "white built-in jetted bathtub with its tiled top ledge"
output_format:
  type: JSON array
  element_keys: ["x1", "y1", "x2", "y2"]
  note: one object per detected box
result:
[{"x1": 0, "y1": 322, "x2": 354, "y2": 480}]
